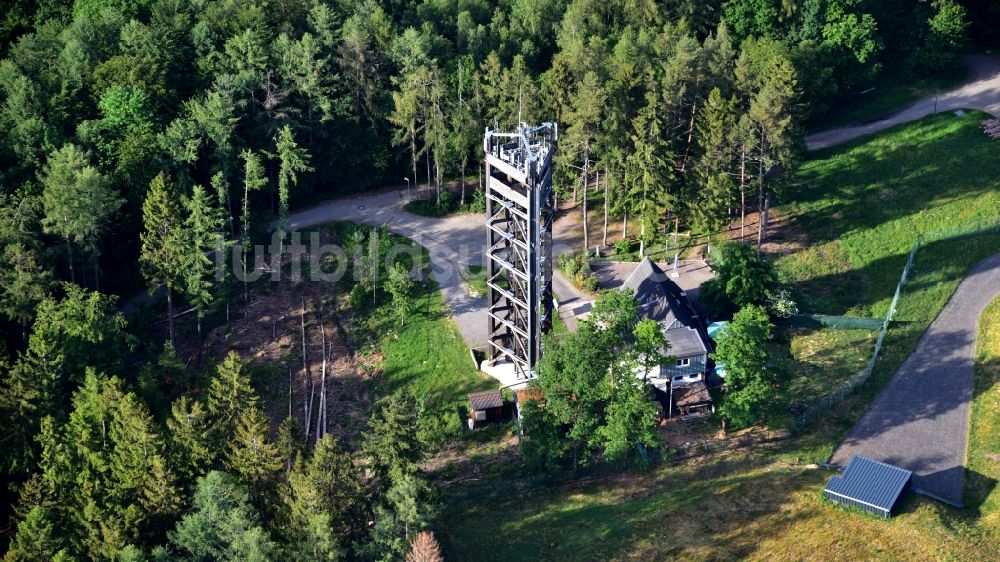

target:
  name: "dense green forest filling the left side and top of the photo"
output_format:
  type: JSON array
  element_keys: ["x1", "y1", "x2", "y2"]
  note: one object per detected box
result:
[{"x1": 0, "y1": 0, "x2": 984, "y2": 562}]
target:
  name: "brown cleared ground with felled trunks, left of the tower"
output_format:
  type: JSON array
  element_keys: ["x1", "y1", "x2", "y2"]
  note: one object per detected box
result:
[{"x1": 203, "y1": 228, "x2": 381, "y2": 441}]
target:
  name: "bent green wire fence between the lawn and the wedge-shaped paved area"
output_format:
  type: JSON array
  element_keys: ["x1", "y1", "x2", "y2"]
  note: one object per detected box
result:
[{"x1": 795, "y1": 219, "x2": 1000, "y2": 431}]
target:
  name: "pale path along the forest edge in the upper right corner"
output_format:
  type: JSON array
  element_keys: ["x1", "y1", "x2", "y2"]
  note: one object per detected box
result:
[{"x1": 806, "y1": 55, "x2": 1000, "y2": 150}]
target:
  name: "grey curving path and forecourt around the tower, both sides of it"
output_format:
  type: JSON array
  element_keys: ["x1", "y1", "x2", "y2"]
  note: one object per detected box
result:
[{"x1": 288, "y1": 189, "x2": 590, "y2": 347}]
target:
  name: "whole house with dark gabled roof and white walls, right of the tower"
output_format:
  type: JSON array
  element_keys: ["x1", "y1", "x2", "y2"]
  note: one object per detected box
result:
[{"x1": 621, "y1": 257, "x2": 713, "y2": 410}]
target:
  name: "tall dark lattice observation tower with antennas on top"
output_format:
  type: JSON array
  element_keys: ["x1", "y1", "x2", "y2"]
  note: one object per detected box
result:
[{"x1": 483, "y1": 123, "x2": 558, "y2": 380}]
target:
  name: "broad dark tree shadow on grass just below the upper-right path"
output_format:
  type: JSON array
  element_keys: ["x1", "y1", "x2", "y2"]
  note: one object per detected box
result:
[{"x1": 779, "y1": 114, "x2": 1000, "y2": 247}]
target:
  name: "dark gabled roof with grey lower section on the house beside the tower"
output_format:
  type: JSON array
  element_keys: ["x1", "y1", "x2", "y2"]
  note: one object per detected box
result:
[{"x1": 621, "y1": 256, "x2": 708, "y2": 357}]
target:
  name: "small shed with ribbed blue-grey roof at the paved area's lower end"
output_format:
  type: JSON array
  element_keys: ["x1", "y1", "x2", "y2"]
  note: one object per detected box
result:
[{"x1": 823, "y1": 455, "x2": 913, "y2": 518}]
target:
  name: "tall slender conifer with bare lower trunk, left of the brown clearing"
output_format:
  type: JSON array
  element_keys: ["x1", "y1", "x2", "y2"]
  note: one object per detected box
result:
[{"x1": 139, "y1": 172, "x2": 187, "y2": 343}]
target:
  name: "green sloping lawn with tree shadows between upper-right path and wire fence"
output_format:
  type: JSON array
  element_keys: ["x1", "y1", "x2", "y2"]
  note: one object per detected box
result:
[{"x1": 776, "y1": 112, "x2": 1000, "y2": 317}]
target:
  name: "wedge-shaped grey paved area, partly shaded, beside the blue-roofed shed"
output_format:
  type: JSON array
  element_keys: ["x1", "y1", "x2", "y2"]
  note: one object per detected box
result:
[{"x1": 830, "y1": 254, "x2": 1000, "y2": 504}]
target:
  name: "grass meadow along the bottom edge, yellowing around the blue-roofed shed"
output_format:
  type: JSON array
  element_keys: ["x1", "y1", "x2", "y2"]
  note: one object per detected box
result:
[{"x1": 440, "y1": 446, "x2": 1000, "y2": 561}]
